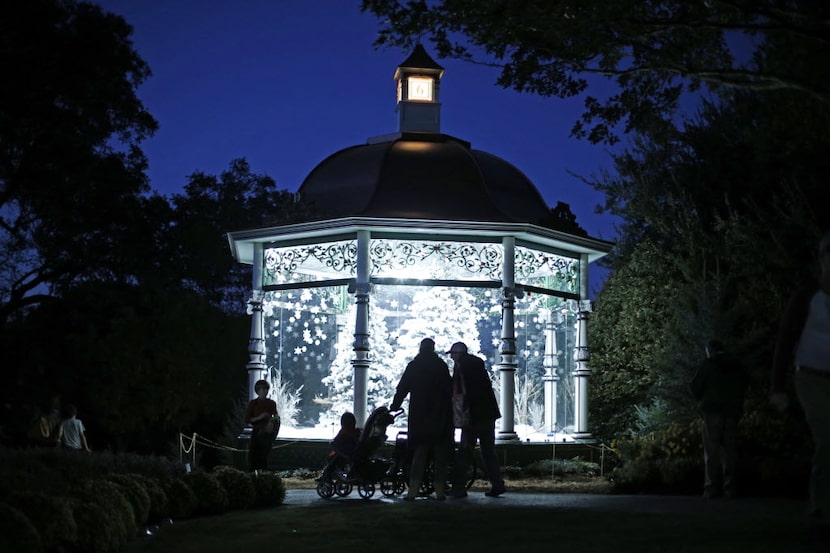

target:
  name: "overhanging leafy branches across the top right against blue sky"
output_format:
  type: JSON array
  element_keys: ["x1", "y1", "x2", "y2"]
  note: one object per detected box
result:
[{"x1": 362, "y1": 0, "x2": 830, "y2": 143}]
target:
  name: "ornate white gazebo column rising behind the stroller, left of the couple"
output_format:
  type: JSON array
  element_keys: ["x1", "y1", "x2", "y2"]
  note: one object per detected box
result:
[{"x1": 349, "y1": 230, "x2": 371, "y2": 426}]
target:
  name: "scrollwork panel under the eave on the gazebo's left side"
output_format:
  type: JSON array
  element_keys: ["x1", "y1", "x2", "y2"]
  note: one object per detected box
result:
[{"x1": 262, "y1": 240, "x2": 357, "y2": 286}]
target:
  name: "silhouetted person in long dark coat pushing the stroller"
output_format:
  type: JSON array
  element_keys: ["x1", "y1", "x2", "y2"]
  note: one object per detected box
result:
[{"x1": 389, "y1": 338, "x2": 453, "y2": 501}]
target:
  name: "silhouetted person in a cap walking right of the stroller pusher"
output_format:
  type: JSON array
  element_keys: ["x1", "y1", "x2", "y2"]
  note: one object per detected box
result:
[{"x1": 447, "y1": 342, "x2": 505, "y2": 498}]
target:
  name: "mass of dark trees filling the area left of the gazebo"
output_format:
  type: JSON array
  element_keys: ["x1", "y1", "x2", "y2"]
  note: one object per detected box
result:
[{"x1": 0, "y1": 6, "x2": 320, "y2": 452}]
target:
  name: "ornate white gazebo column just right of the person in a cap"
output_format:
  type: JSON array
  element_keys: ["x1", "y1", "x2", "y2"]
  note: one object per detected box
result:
[{"x1": 496, "y1": 236, "x2": 524, "y2": 441}]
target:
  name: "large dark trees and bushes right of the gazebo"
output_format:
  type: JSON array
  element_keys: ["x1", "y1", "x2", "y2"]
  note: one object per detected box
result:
[{"x1": 590, "y1": 84, "x2": 830, "y2": 446}]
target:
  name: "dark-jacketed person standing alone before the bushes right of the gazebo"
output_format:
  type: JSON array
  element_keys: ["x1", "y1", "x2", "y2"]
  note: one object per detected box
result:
[{"x1": 689, "y1": 340, "x2": 749, "y2": 499}]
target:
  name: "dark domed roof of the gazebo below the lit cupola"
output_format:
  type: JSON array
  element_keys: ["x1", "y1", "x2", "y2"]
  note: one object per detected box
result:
[{"x1": 299, "y1": 132, "x2": 549, "y2": 224}]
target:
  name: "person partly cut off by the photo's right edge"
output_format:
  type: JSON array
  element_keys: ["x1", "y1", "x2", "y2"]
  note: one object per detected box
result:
[{"x1": 770, "y1": 231, "x2": 830, "y2": 518}]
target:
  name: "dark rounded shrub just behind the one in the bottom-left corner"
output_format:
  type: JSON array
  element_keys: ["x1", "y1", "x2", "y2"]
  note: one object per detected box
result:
[{"x1": 11, "y1": 492, "x2": 78, "y2": 551}]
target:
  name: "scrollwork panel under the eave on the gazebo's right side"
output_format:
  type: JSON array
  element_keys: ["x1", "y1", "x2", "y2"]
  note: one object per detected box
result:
[{"x1": 515, "y1": 245, "x2": 579, "y2": 294}]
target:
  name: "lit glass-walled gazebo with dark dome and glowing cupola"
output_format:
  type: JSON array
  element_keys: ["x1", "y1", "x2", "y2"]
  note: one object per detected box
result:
[{"x1": 228, "y1": 45, "x2": 611, "y2": 441}]
